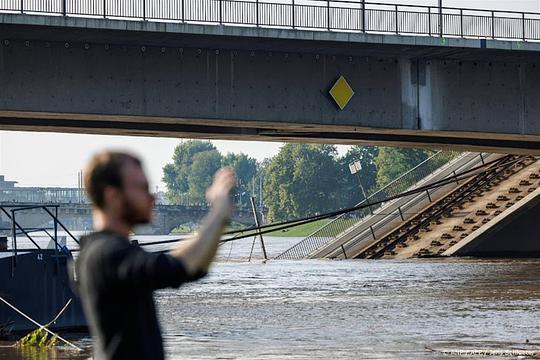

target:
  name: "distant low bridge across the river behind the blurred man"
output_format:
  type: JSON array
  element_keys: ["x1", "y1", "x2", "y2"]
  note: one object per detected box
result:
[{"x1": 0, "y1": 203, "x2": 254, "y2": 235}]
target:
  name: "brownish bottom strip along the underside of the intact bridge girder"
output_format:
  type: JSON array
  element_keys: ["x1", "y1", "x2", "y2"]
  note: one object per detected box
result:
[{"x1": 5, "y1": 111, "x2": 540, "y2": 154}]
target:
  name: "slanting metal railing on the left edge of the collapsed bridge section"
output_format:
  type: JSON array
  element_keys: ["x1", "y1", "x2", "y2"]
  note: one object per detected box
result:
[{"x1": 276, "y1": 151, "x2": 460, "y2": 260}]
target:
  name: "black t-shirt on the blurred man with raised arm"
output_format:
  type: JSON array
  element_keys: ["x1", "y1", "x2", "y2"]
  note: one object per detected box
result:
[{"x1": 76, "y1": 231, "x2": 203, "y2": 360}]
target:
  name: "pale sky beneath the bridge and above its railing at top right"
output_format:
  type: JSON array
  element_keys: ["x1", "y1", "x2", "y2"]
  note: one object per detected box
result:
[{"x1": 0, "y1": 0, "x2": 540, "y2": 190}]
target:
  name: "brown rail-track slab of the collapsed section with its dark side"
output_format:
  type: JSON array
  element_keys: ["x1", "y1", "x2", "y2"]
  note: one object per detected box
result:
[{"x1": 361, "y1": 157, "x2": 540, "y2": 259}]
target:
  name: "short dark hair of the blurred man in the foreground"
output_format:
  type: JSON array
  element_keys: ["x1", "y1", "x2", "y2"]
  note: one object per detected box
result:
[{"x1": 84, "y1": 151, "x2": 142, "y2": 209}]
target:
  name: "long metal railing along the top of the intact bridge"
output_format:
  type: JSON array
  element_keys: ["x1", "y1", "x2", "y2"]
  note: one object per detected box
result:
[{"x1": 0, "y1": 0, "x2": 540, "y2": 41}]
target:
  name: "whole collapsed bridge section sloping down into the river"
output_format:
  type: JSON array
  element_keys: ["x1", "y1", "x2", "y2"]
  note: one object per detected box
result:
[{"x1": 277, "y1": 153, "x2": 540, "y2": 259}]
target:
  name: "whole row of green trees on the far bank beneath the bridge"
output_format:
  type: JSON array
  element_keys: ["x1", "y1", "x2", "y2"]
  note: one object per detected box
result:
[{"x1": 163, "y1": 140, "x2": 452, "y2": 221}]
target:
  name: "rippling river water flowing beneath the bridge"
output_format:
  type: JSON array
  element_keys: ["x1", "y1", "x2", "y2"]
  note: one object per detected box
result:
[{"x1": 0, "y1": 238, "x2": 540, "y2": 359}]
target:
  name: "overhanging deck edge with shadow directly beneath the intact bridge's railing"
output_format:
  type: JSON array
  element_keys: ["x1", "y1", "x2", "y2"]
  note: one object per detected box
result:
[{"x1": 0, "y1": 13, "x2": 540, "y2": 60}]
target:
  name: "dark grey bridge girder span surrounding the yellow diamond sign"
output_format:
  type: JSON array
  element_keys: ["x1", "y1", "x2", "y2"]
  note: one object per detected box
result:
[{"x1": 0, "y1": 14, "x2": 540, "y2": 153}]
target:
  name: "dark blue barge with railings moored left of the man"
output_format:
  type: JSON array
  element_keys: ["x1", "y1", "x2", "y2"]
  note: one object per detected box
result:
[{"x1": 0, "y1": 205, "x2": 86, "y2": 336}]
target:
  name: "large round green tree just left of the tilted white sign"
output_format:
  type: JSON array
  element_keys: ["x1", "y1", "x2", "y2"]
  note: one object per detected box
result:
[{"x1": 264, "y1": 144, "x2": 339, "y2": 221}]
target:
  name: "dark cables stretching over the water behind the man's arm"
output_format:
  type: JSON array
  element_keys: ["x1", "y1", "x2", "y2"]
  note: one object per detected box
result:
[{"x1": 140, "y1": 156, "x2": 523, "y2": 250}]
